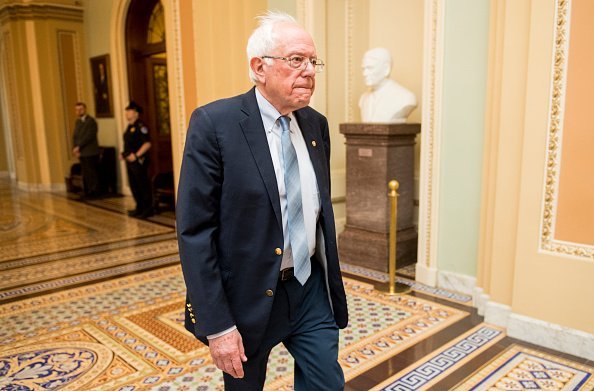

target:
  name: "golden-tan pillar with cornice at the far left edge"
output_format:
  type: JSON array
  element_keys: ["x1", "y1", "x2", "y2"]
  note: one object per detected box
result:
[{"x1": 0, "y1": 0, "x2": 84, "y2": 189}]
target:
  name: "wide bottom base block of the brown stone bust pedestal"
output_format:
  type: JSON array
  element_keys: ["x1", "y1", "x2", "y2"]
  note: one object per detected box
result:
[{"x1": 338, "y1": 225, "x2": 418, "y2": 273}]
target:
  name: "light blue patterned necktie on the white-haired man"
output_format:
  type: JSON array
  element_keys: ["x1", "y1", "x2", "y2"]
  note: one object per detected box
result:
[{"x1": 278, "y1": 115, "x2": 311, "y2": 285}]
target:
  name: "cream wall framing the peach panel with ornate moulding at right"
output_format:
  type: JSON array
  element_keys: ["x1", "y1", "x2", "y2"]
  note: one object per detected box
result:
[{"x1": 477, "y1": 0, "x2": 594, "y2": 336}]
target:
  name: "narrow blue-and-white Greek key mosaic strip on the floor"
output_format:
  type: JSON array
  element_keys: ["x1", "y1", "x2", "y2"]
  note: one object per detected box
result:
[{"x1": 371, "y1": 323, "x2": 505, "y2": 391}]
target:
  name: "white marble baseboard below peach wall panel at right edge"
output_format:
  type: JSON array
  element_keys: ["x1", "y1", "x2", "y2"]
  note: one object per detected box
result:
[{"x1": 507, "y1": 313, "x2": 594, "y2": 360}]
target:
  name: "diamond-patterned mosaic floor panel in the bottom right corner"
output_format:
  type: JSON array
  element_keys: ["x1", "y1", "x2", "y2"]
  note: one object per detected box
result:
[{"x1": 455, "y1": 344, "x2": 594, "y2": 391}]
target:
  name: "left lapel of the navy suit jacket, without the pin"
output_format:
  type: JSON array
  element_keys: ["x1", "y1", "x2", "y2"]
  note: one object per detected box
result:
[{"x1": 239, "y1": 88, "x2": 283, "y2": 231}]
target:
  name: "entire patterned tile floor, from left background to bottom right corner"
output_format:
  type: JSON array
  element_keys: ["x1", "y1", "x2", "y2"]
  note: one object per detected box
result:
[{"x1": 0, "y1": 181, "x2": 594, "y2": 391}]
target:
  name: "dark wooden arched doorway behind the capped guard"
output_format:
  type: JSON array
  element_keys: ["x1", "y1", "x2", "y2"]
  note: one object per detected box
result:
[{"x1": 125, "y1": 0, "x2": 173, "y2": 186}]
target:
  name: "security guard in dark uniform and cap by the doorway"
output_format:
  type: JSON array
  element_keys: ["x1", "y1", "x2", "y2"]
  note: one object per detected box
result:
[{"x1": 121, "y1": 101, "x2": 154, "y2": 219}]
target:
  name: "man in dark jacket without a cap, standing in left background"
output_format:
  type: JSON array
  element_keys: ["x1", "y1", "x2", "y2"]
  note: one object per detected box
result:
[{"x1": 72, "y1": 102, "x2": 99, "y2": 198}]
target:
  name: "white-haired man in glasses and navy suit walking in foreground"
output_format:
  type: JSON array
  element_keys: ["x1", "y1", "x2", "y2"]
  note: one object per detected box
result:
[{"x1": 176, "y1": 12, "x2": 348, "y2": 391}]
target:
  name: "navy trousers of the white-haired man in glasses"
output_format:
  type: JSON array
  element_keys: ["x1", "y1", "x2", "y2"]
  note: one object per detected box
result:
[{"x1": 223, "y1": 258, "x2": 344, "y2": 391}]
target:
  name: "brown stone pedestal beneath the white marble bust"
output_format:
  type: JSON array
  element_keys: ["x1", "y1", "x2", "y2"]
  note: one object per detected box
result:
[{"x1": 338, "y1": 123, "x2": 421, "y2": 272}]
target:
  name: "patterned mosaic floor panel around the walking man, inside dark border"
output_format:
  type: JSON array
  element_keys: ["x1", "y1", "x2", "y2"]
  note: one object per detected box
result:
[{"x1": 0, "y1": 266, "x2": 468, "y2": 390}]
